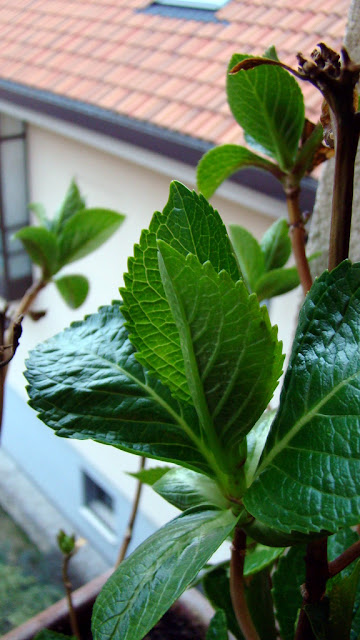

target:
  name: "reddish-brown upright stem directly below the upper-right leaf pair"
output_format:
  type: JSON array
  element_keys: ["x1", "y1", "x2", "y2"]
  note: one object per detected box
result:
[{"x1": 285, "y1": 185, "x2": 312, "y2": 295}]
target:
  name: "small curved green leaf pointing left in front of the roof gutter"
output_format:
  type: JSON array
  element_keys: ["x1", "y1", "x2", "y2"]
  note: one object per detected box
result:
[{"x1": 197, "y1": 144, "x2": 281, "y2": 198}]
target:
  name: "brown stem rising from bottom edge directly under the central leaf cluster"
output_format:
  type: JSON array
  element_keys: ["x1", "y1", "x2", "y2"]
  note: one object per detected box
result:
[{"x1": 230, "y1": 527, "x2": 260, "y2": 640}]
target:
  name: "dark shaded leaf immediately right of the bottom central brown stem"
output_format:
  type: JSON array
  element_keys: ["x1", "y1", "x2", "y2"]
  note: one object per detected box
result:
[{"x1": 246, "y1": 569, "x2": 278, "y2": 640}]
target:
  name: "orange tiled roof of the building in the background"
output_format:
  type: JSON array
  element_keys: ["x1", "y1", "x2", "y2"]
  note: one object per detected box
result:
[{"x1": 0, "y1": 0, "x2": 350, "y2": 143}]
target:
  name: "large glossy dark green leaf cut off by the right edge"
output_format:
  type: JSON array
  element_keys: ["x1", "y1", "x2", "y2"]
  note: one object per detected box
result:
[{"x1": 244, "y1": 261, "x2": 360, "y2": 533}]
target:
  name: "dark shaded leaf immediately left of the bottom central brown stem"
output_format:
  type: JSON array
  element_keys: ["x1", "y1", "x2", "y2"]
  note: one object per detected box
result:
[{"x1": 203, "y1": 567, "x2": 244, "y2": 640}]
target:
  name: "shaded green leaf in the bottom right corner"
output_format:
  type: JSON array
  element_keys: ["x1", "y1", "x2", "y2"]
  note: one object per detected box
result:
[{"x1": 327, "y1": 560, "x2": 360, "y2": 640}]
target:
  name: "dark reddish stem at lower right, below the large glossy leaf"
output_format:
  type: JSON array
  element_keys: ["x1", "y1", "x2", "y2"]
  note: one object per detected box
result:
[{"x1": 295, "y1": 538, "x2": 330, "y2": 640}]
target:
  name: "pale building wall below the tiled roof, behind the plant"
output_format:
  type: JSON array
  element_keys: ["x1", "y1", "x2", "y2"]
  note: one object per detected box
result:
[{"x1": 0, "y1": 114, "x2": 298, "y2": 557}]
